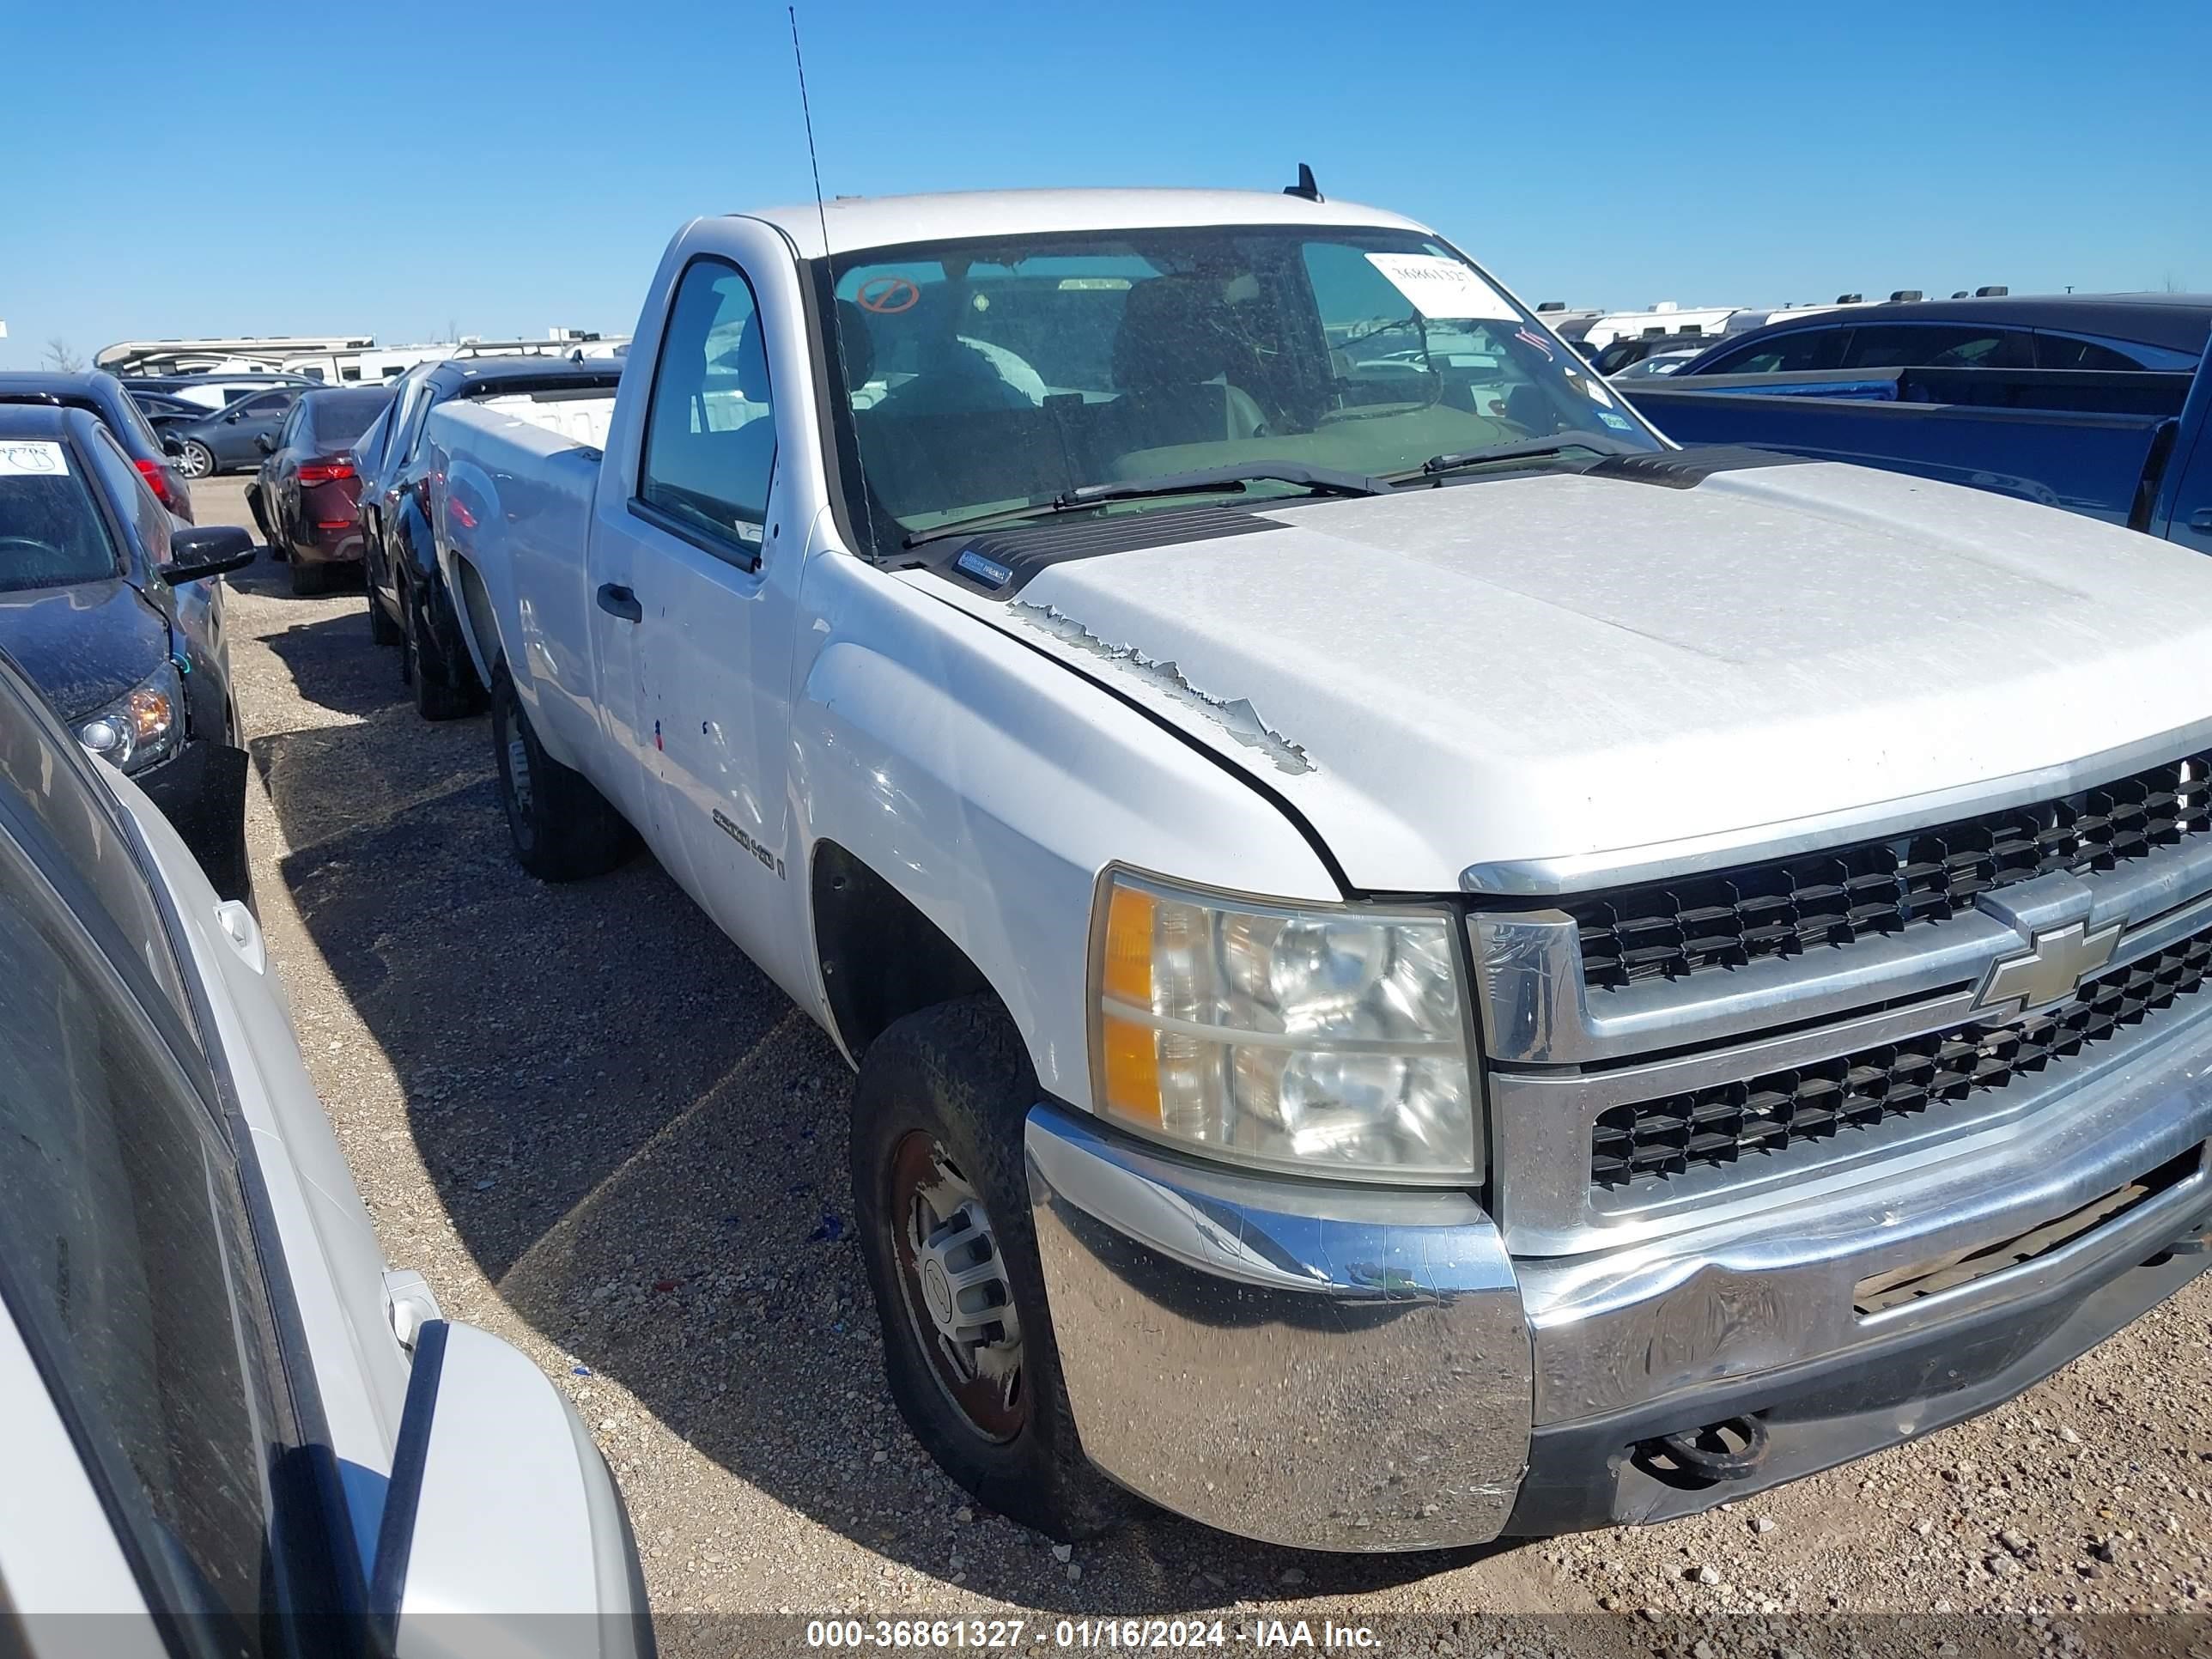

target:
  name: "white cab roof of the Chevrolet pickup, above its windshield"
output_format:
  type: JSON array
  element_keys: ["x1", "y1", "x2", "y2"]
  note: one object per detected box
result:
[{"x1": 732, "y1": 188, "x2": 1429, "y2": 258}]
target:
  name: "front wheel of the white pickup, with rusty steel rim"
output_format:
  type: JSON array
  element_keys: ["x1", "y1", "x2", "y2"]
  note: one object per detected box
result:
[{"x1": 852, "y1": 998, "x2": 1134, "y2": 1541}]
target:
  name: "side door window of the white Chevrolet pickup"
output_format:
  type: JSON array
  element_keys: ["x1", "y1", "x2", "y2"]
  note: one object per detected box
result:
[{"x1": 637, "y1": 258, "x2": 776, "y2": 568}]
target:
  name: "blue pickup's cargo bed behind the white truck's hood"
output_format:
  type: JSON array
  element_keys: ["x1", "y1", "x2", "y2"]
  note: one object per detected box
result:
[{"x1": 1631, "y1": 369, "x2": 2192, "y2": 525}]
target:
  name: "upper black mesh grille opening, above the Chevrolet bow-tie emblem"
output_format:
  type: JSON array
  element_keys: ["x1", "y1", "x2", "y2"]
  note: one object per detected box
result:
[{"x1": 1566, "y1": 752, "x2": 2212, "y2": 988}]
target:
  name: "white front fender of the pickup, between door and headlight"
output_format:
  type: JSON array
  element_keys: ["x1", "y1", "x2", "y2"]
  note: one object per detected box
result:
[{"x1": 792, "y1": 553, "x2": 1343, "y2": 1106}]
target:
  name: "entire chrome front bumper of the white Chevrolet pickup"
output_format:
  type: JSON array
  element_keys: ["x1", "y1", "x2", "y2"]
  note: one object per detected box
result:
[{"x1": 1026, "y1": 1000, "x2": 2212, "y2": 1551}]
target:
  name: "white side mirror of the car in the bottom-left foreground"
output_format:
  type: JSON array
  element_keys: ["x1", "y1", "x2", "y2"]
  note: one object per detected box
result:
[{"x1": 369, "y1": 1318, "x2": 654, "y2": 1659}]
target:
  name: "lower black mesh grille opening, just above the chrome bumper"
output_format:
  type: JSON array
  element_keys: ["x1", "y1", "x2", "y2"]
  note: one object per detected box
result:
[{"x1": 1590, "y1": 929, "x2": 2212, "y2": 1188}]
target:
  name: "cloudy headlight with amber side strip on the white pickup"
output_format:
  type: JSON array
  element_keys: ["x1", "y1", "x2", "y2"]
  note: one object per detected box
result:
[{"x1": 1091, "y1": 872, "x2": 1482, "y2": 1182}]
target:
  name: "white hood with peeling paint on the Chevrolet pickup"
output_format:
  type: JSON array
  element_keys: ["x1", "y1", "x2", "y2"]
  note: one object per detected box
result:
[{"x1": 911, "y1": 465, "x2": 2212, "y2": 891}]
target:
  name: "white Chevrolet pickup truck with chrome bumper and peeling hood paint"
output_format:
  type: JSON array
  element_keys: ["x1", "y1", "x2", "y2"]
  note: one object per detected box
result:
[{"x1": 427, "y1": 191, "x2": 2212, "y2": 1551}]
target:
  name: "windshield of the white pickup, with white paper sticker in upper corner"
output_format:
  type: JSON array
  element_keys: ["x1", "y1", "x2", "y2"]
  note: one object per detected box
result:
[{"x1": 834, "y1": 226, "x2": 1659, "y2": 550}]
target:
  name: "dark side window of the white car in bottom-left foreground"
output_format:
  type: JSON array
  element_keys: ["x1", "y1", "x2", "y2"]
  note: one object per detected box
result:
[{"x1": 0, "y1": 836, "x2": 281, "y2": 1655}]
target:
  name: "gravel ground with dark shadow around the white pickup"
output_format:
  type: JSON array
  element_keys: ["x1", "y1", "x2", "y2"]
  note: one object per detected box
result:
[{"x1": 195, "y1": 477, "x2": 2212, "y2": 1659}]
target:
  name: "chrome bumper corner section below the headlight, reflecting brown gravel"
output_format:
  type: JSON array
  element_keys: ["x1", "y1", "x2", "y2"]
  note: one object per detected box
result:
[{"x1": 1026, "y1": 1106, "x2": 1531, "y2": 1551}]
